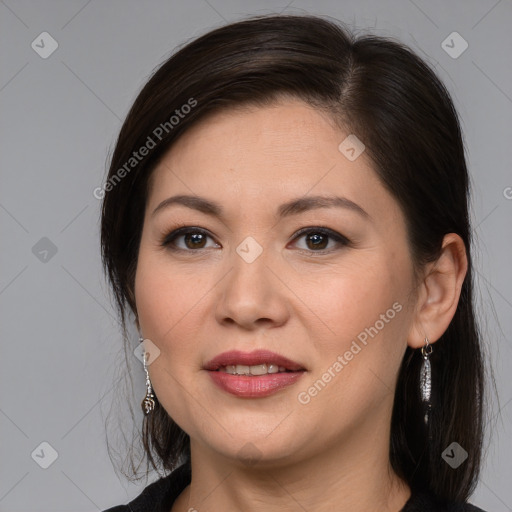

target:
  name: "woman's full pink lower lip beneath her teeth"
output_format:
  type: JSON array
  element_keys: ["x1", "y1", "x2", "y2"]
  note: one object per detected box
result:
[{"x1": 208, "y1": 371, "x2": 305, "y2": 398}]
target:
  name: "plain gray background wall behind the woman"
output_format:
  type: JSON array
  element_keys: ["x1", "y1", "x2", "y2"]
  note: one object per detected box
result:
[{"x1": 0, "y1": 0, "x2": 512, "y2": 512}]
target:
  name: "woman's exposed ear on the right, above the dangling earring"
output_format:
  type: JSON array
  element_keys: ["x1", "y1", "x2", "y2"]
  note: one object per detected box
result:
[{"x1": 407, "y1": 233, "x2": 468, "y2": 348}]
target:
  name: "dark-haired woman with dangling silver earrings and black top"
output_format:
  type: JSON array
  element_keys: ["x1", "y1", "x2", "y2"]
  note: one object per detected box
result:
[{"x1": 101, "y1": 15, "x2": 484, "y2": 512}]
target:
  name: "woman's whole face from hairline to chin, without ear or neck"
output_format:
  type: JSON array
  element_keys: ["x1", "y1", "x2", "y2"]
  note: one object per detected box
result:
[{"x1": 135, "y1": 100, "x2": 420, "y2": 464}]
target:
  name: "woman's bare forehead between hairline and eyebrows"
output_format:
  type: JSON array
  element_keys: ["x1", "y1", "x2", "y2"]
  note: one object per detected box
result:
[{"x1": 144, "y1": 100, "x2": 396, "y2": 226}]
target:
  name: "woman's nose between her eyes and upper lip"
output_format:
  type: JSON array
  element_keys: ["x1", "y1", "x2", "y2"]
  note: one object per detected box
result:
[{"x1": 216, "y1": 247, "x2": 290, "y2": 330}]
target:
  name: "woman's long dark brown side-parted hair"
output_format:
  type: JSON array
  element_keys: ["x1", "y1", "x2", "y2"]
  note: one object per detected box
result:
[{"x1": 101, "y1": 15, "x2": 484, "y2": 501}]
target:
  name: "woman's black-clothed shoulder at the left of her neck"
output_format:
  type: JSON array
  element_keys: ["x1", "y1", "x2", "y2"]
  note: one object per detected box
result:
[{"x1": 103, "y1": 463, "x2": 190, "y2": 512}]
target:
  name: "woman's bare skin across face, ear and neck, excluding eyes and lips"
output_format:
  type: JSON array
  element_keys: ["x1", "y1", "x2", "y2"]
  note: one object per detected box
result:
[{"x1": 135, "y1": 99, "x2": 467, "y2": 512}]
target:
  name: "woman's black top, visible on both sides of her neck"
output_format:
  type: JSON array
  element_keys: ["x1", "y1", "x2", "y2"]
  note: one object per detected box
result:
[{"x1": 103, "y1": 462, "x2": 485, "y2": 512}]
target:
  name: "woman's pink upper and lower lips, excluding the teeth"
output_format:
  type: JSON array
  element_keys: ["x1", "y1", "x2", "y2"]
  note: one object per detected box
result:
[{"x1": 204, "y1": 350, "x2": 306, "y2": 398}]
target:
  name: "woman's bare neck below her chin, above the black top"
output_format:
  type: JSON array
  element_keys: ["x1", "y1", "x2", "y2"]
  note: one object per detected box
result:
[{"x1": 172, "y1": 412, "x2": 411, "y2": 512}]
